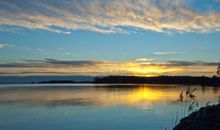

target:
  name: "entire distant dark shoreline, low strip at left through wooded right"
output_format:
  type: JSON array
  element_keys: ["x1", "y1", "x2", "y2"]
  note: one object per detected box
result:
[{"x1": 0, "y1": 76, "x2": 220, "y2": 87}]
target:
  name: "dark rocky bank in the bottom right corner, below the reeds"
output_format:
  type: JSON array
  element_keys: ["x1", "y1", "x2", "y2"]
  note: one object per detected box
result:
[{"x1": 173, "y1": 103, "x2": 220, "y2": 130}]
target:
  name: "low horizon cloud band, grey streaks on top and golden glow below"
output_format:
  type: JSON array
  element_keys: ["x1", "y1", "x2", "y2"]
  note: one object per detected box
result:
[{"x1": 0, "y1": 58, "x2": 218, "y2": 76}]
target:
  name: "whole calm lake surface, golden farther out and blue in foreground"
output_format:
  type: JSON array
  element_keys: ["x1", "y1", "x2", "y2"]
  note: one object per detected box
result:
[{"x1": 0, "y1": 84, "x2": 220, "y2": 130}]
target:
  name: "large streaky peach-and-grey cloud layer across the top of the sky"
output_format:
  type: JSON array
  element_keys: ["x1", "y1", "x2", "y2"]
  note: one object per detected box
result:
[{"x1": 0, "y1": 0, "x2": 220, "y2": 34}]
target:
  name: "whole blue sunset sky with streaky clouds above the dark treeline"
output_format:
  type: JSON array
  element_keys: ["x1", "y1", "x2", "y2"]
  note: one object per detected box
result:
[{"x1": 0, "y1": 0, "x2": 220, "y2": 76}]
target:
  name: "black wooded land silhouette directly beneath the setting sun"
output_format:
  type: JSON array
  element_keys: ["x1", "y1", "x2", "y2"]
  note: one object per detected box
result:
[{"x1": 93, "y1": 76, "x2": 220, "y2": 87}]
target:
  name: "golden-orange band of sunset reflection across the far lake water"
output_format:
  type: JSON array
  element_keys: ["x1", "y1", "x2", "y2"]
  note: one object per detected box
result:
[{"x1": 0, "y1": 85, "x2": 219, "y2": 107}]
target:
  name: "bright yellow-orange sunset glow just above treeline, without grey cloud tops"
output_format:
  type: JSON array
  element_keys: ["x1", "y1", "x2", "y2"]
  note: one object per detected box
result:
[{"x1": 0, "y1": 58, "x2": 216, "y2": 76}]
